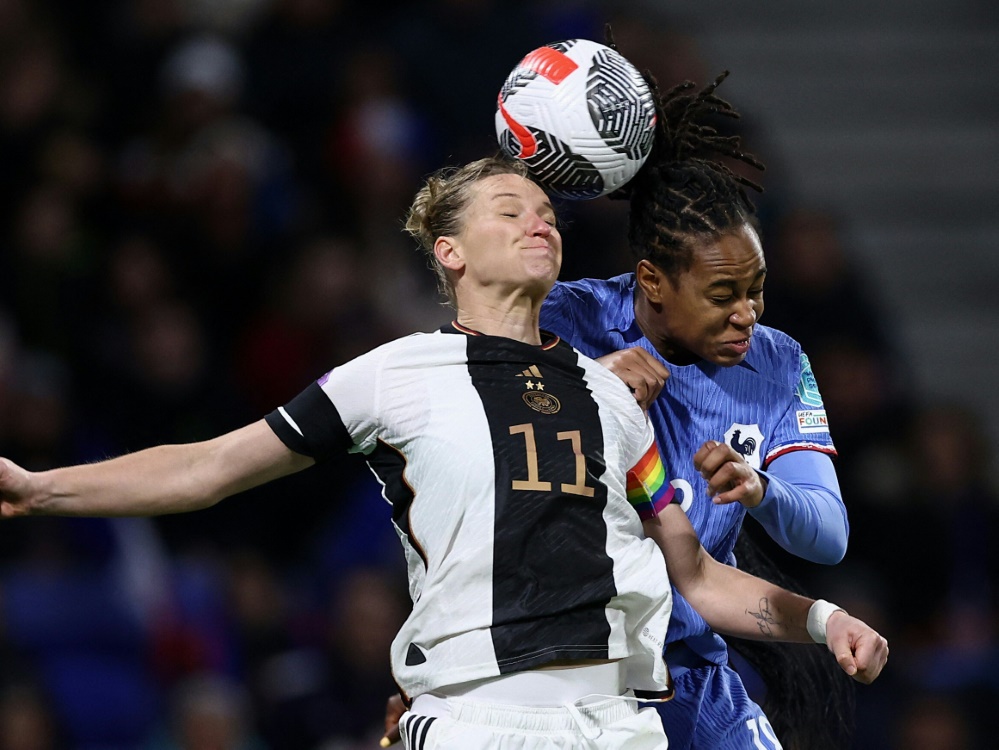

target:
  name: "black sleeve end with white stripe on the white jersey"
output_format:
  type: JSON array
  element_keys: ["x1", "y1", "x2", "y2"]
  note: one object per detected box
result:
[{"x1": 264, "y1": 383, "x2": 354, "y2": 461}]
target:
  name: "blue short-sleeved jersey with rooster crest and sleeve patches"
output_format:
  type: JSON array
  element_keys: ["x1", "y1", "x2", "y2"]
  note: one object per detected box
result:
[{"x1": 541, "y1": 274, "x2": 836, "y2": 664}]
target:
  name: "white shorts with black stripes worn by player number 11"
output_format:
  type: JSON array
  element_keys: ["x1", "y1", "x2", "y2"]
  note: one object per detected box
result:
[{"x1": 399, "y1": 667, "x2": 667, "y2": 750}]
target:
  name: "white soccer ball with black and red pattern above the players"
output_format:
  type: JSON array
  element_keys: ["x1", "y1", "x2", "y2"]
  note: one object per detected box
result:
[{"x1": 496, "y1": 39, "x2": 656, "y2": 200}]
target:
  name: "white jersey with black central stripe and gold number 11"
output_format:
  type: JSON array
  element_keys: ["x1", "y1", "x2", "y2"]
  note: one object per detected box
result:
[{"x1": 267, "y1": 324, "x2": 671, "y2": 698}]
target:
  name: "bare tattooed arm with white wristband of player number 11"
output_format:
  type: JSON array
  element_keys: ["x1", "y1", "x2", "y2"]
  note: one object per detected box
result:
[{"x1": 644, "y1": 504, "x2": 888, "y2": 683}]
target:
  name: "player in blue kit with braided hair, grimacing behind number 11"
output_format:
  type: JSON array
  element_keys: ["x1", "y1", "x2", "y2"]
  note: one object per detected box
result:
[{"x1": 541, "y1": 75, "x2": 849, "y2": 750}]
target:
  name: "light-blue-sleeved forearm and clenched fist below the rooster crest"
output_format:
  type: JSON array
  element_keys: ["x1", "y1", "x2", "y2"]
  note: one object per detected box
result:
[{"x1": 694, "y1": 440, "x2": 850, "y2": 565}]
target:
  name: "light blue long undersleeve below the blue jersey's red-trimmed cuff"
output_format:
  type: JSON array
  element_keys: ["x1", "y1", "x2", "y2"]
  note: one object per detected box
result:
[{"x1": 749, "y1": 450, "x2": 850, "y2": 565}]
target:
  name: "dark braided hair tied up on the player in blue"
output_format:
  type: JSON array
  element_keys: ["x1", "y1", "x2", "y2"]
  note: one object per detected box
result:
[{"x1": 619, "y1": 71, "x2": 764, "y2": 276}]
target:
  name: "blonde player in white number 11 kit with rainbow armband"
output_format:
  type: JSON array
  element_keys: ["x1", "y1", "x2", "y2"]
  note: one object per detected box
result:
[{"x1": 0, "y1": 159, "x2": 887, "y2": 750}]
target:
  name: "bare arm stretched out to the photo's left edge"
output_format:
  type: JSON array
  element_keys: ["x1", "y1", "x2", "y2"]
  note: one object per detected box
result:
[{"x1": 0, "y1": 420, "x2": 314, "y2": 518}]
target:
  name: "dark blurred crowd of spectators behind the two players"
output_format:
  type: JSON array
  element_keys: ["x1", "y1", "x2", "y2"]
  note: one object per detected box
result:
[{"x1": 0, "y1": 0, "x2": 999, "y2": 750}]
